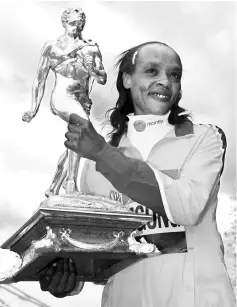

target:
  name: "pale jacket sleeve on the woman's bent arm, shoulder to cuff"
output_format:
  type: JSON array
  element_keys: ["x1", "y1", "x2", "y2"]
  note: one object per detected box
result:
[{"x1": 146, "y1": 126, "x2": 226, "y2": 225}]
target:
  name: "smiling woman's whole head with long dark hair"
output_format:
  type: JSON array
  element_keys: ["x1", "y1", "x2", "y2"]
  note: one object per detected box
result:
[{"x1": 107, "y1": 42, "x2": 189, "y2": 145}]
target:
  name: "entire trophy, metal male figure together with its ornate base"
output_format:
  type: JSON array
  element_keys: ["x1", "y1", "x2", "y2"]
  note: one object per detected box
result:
[{"x1": 0, "y1": 8, "x2": 156, "y2": 284}]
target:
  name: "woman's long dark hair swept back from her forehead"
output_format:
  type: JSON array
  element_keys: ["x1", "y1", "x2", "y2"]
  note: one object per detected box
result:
[{"x1": 106, "y1": 41, "x2": 190, "y2": 147}]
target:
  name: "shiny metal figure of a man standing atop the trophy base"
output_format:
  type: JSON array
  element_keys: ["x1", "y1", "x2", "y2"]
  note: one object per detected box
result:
[{"x1": 22, "y1": 8, "x2": 107, "y2": 197}]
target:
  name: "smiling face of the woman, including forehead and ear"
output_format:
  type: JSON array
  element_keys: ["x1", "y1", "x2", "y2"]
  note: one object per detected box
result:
[{"x1": 123, "y1": 44, "x2": 182, "y2": 115}]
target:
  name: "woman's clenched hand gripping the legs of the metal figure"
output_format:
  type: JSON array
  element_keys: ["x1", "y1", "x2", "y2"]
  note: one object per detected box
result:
[{"x1": 64, "y1": 113, "x2": 106, "y2": 161}]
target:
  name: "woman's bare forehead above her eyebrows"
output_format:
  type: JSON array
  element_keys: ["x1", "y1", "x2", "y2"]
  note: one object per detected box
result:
[{"x1": 137, "y1": 43, "x2": 182, "y2": 67}]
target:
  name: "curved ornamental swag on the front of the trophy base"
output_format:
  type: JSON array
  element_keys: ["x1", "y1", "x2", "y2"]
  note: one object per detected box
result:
[{"x1": 60, "y1": 229, "x2": 124, "y2": 251}]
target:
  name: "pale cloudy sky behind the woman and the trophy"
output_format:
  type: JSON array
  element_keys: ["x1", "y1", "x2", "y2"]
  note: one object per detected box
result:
[{"x1": 0, "y1": 1, "x2": 236, "y2": 307}]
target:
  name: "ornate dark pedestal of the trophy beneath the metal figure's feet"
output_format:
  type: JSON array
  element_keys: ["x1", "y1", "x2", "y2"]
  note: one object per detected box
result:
[{"x1": 0, "y1": 194, "x2": 159, "y2": 284}]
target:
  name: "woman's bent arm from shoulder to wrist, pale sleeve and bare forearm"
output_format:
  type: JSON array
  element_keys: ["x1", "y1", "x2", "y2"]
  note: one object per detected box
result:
[{"x1": 96, "y1": 126, "x2": 226, "y2": 225}]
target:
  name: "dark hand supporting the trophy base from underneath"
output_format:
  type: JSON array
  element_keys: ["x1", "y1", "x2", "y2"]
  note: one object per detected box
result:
[{"x1": 40, "y1": 258, "x2": 77, "y2": 298}]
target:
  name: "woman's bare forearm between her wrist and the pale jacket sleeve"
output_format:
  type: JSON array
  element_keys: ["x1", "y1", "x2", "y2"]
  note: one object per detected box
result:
[{"x1": 96, "y1": 144, "x2": 167, "y2": 217}]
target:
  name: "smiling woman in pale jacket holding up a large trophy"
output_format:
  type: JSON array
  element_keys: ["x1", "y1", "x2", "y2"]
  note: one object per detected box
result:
[{"x1": 40, "y1": 42, "x2": 235, "y2": 307}]
